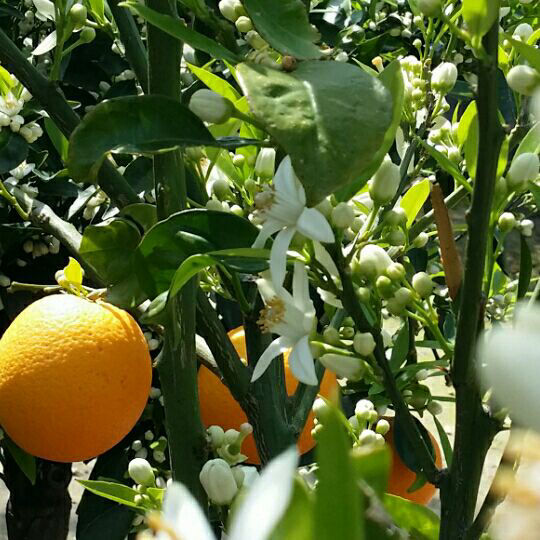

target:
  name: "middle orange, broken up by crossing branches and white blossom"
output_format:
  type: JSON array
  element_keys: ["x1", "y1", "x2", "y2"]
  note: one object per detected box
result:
[{"x1": 198, "y1": 327, "x2": 336, "y2": 464}]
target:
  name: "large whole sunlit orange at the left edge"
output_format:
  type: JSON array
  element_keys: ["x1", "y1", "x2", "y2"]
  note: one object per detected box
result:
[{"x1": 0, "y1": 294, "x2": 152, "y2": 462}]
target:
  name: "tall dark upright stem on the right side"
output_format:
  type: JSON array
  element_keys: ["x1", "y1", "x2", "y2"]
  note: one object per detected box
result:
[{"x1": 439, "y1": 21, "x2": 504, "y2": 540}]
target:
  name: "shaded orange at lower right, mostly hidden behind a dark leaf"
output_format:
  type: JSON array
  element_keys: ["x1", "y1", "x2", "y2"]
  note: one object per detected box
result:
[{"x1": 385, "y1": 418, "x2": 442, "y2": 504}]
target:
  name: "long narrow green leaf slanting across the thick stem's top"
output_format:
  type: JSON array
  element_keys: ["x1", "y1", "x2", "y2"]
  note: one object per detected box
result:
[{"x1": 120, "y1": 0, "x2": 240, "y2": 64}]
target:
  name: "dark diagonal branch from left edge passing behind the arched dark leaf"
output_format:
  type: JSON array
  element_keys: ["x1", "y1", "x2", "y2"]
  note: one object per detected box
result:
[{"x1": 0, "y1": 29, "x2": 140, "y2": 207}]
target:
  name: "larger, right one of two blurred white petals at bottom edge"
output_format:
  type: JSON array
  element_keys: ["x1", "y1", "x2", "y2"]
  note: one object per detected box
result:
[{"x1": 226, "y1": 447, "x2": 298, "y2": 540}]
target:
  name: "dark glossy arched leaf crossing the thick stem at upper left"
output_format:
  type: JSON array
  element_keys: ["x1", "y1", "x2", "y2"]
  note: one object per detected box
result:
[{"x1": 68, "y1": 96, "x2": 258, "y2": 182}]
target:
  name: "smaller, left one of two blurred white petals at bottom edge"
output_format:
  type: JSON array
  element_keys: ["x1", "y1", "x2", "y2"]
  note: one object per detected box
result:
[{"x1": 158, "y1": 482, "x2": 215, "y2": 540}]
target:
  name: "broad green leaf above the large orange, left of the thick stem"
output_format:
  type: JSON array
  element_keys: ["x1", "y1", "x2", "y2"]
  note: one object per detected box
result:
[{"x1": 79, "y1": 219, "x2": 141, "y2": 285}]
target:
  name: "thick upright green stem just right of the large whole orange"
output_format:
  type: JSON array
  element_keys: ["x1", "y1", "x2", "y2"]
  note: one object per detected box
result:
[{"x1": 147, "y1": 0, "x2": 207, "y2": 507}]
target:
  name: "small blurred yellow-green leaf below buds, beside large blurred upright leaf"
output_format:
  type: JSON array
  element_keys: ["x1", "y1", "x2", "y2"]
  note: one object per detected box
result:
[{"x1": 351, "y1": 444, "x2": 392, "y2": 497}]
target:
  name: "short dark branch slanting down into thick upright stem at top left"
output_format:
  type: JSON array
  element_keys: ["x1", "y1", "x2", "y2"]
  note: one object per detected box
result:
[{"x1": 109, "y1": 0, "x2": 148, "y2": 94}]
